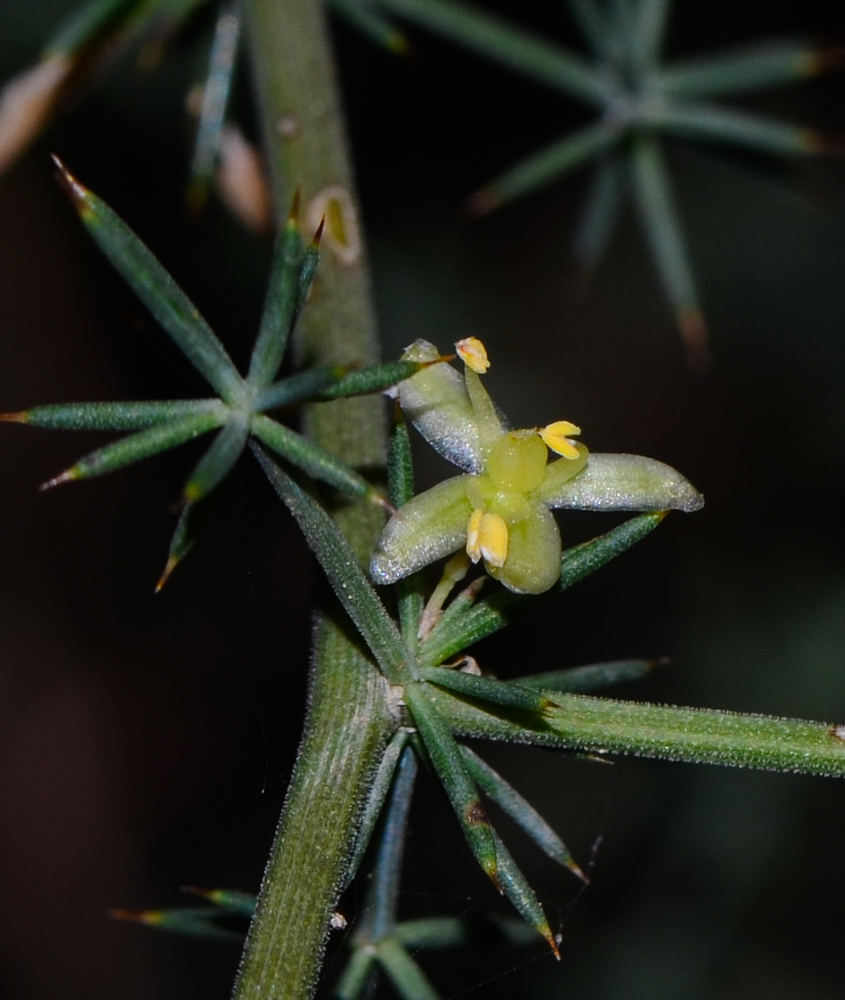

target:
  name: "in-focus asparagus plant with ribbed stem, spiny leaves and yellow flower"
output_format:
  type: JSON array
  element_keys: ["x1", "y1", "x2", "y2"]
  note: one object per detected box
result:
[{"x1": 1, "y1": 0, "x2": 845, "y2": 1000}]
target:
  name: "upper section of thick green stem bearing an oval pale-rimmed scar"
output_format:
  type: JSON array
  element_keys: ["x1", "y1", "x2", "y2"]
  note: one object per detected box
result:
[{"x1": 246, "y1": 0, "x2": 380, "y2": 478}]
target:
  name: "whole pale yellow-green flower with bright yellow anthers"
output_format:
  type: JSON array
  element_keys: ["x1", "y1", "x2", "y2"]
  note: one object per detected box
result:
[{"x1": 370, "y1": 337, "x2": 704, "y2": 594}]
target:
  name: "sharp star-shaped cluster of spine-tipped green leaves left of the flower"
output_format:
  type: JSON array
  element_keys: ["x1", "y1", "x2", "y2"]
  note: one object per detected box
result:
[{"x1": 0, "y1": 160, "x2": 436, "y2": 587}]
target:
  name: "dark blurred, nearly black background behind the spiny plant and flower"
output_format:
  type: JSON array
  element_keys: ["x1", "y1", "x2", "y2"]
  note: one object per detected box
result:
[{"x1": 0, "y1": 0, "x2": 845, "y2": 1000}]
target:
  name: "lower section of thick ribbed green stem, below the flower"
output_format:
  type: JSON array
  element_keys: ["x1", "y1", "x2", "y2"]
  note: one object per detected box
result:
[{"x1": 235, "y1": 619, "x2": 390, "y2": 1000}]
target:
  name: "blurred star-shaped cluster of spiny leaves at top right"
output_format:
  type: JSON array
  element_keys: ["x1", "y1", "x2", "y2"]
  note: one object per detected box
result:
[{"x1": 378, "y1": 0, "x2": 842, "y2": 366}]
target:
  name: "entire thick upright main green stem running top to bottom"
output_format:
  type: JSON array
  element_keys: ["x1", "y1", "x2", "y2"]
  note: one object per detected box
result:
[{"x1": 235, "y1": 0, "x2": 393, "y2": 1000}]
